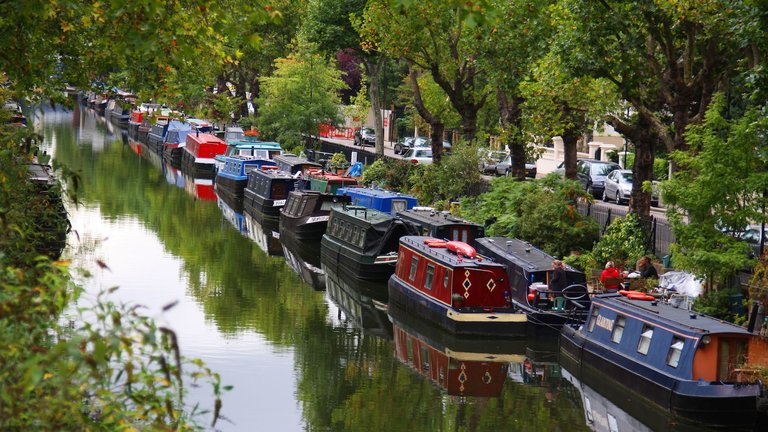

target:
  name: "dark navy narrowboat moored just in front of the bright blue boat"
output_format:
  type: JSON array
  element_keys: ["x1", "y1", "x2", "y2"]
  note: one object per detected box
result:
[{"x1": 243, "y1": 169, "x2": 296, "y2": 222}]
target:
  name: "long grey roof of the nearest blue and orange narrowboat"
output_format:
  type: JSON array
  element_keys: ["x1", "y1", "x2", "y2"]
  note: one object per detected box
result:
[{"x1": 592, "y1": 294, "x2": 751, "y2": 335}]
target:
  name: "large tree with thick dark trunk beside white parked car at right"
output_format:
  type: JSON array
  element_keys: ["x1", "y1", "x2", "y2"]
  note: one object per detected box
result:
[{"x1": 556, "y1": 0, "x2": 760, "y2": 215}]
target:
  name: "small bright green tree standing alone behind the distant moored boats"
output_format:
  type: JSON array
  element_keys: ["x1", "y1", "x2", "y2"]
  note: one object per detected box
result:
[{"x1": 258, "y1": 41, "x2": 344, "y2": 149}]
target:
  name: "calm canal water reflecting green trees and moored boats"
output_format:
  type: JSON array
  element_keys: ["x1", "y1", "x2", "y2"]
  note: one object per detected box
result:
[{"x1": 34, "y1": 107, "x2": 728, "y2": 432}]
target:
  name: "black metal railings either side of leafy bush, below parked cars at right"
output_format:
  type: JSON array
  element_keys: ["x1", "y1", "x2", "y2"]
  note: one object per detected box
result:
[{"x1": 577, "y1": 202, "x2": 675, "y2": 258}]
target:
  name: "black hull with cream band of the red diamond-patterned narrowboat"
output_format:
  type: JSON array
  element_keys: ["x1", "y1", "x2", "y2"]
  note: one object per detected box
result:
[{"x1": 389, "y1": 275, "x2": 527, "y2": 337}]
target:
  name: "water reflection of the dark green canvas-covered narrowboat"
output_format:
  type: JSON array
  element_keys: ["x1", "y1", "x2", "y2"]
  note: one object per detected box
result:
[{"x1": 321, "y1": 261, "x2": 392, "y2": 339}]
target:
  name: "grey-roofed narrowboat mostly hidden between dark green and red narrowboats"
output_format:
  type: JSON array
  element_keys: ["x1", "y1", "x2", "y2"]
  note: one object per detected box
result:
[{"x1": 397, "y1": 207, "x2": 485, "y2": 243}]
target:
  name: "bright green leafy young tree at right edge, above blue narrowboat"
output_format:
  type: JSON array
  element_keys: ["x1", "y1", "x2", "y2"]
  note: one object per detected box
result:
[{"x1": 662, "y1": 95, "x2": 768, "y2": 285}]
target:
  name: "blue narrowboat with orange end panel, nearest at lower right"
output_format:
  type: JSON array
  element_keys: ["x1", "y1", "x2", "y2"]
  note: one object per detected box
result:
[{"x1": 560, "y1": 291, "x2": 766, "y2": 428}]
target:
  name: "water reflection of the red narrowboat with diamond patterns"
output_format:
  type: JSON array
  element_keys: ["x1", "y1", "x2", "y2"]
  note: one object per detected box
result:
[{"x1": 389, "y1": 305, "x2": 527, "y2": 397}]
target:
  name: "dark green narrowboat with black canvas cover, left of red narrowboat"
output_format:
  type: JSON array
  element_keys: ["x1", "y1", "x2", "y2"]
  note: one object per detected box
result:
[{"x1": 320, "y1": 206, "x2": 417, "y2": 281}]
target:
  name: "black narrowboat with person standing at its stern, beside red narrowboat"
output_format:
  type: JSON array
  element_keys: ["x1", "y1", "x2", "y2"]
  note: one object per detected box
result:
[{"x1": 473, "y1": 237, "x2": 591, "y2": 326}]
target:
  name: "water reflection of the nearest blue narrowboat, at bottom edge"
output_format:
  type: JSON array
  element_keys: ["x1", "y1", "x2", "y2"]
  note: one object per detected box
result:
[{"x1": 561, "y1": 367, "x2": 707, "y2": 432}]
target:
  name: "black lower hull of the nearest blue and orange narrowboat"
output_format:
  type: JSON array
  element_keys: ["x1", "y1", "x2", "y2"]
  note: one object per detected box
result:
[{"x1": 560, "y1": 326, "x2": 760, "y2": 428}]
